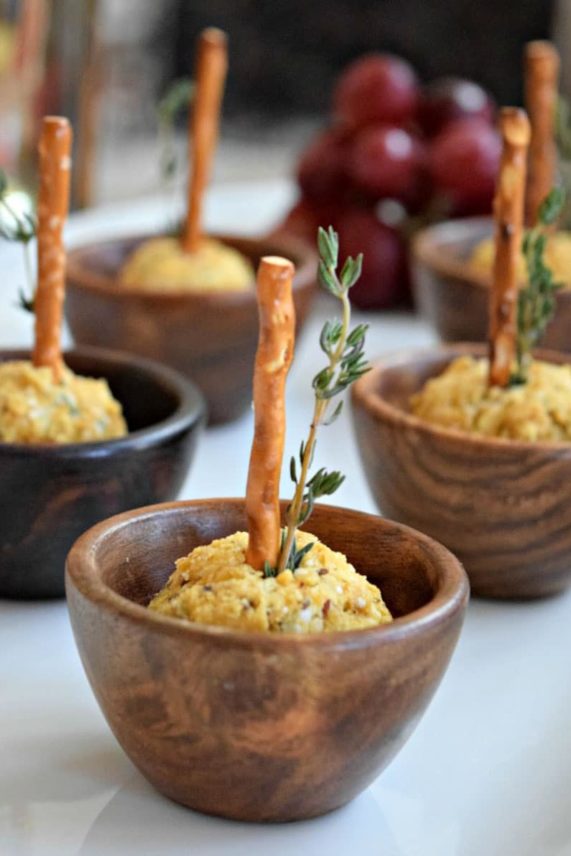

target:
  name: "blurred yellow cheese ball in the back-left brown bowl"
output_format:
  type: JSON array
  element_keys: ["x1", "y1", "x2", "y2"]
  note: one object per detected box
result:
[{"x1": 119, "y1": 238, "x2": 255, "y2": 292}]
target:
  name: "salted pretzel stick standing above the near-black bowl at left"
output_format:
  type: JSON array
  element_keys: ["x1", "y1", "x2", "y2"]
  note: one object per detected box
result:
[{"x1": 33, "y1": 116, "x2": 72, "y2": 380}]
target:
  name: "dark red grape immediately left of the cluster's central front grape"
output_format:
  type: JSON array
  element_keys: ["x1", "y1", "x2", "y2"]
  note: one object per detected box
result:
[{"x1": 297, "y1": 130, "x2": 354, "y2": 201}]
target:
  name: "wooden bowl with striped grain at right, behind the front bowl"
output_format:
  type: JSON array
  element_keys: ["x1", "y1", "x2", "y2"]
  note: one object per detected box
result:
[{"x1": 352, "y1": 344, "x2": 571, "y2": 598}]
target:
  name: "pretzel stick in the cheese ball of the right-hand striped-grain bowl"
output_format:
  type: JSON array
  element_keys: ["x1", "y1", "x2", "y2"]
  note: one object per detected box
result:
[{"x1": 489, "y1": 107, "x2": 530, "y2": 387}]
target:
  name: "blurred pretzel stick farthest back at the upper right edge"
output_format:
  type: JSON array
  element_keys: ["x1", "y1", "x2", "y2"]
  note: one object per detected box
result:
[{"x1": 524, "y1": 41, "x2": 559, "y2": 226}]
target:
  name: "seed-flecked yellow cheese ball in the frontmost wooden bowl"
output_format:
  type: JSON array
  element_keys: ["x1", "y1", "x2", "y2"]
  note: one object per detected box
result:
[{"x1": 149, "y1": 532, "x2": 392, "y2": 633}]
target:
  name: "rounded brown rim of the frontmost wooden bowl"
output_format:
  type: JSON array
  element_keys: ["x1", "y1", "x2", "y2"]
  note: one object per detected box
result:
[{"x1": 65, "y1": 497, "x2": 470, "y2": 651}]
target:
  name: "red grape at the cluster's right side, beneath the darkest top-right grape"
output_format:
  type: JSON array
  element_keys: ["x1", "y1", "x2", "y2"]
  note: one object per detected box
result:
[{"x1": 429, "y1": 119, "x2": 501, "y2": 215}]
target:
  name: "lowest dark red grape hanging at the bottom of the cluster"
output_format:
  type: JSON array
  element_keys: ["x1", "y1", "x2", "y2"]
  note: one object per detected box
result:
[{"x1": 337, "y1": 208, "x2": 407, "y2": 309}]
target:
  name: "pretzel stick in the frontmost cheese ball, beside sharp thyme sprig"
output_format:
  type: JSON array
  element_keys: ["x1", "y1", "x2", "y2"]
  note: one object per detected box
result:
[{"x1": 246, "y1": 256, "x2": 295, "y2": 570}]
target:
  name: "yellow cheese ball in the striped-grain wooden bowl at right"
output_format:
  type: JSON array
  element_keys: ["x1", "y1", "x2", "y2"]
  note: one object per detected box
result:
[{"x1": 410, "y1": 356, "x2": 571, "y2": 443}]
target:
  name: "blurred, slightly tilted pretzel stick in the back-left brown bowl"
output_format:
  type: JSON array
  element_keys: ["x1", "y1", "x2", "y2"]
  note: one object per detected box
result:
[{"x1": 182, "y1": 27, "x2": 228, "y2": 253}]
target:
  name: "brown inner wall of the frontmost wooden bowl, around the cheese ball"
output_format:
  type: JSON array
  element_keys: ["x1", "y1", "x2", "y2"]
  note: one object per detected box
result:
[{"x1": 93, "y1": 500, "x2": 442, "y2": 617}]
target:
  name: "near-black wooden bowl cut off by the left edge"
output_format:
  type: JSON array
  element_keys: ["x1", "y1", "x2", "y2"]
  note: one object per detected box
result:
[{"x1": 0, "y1": 348, "x2": 205, "y2": 598}]
